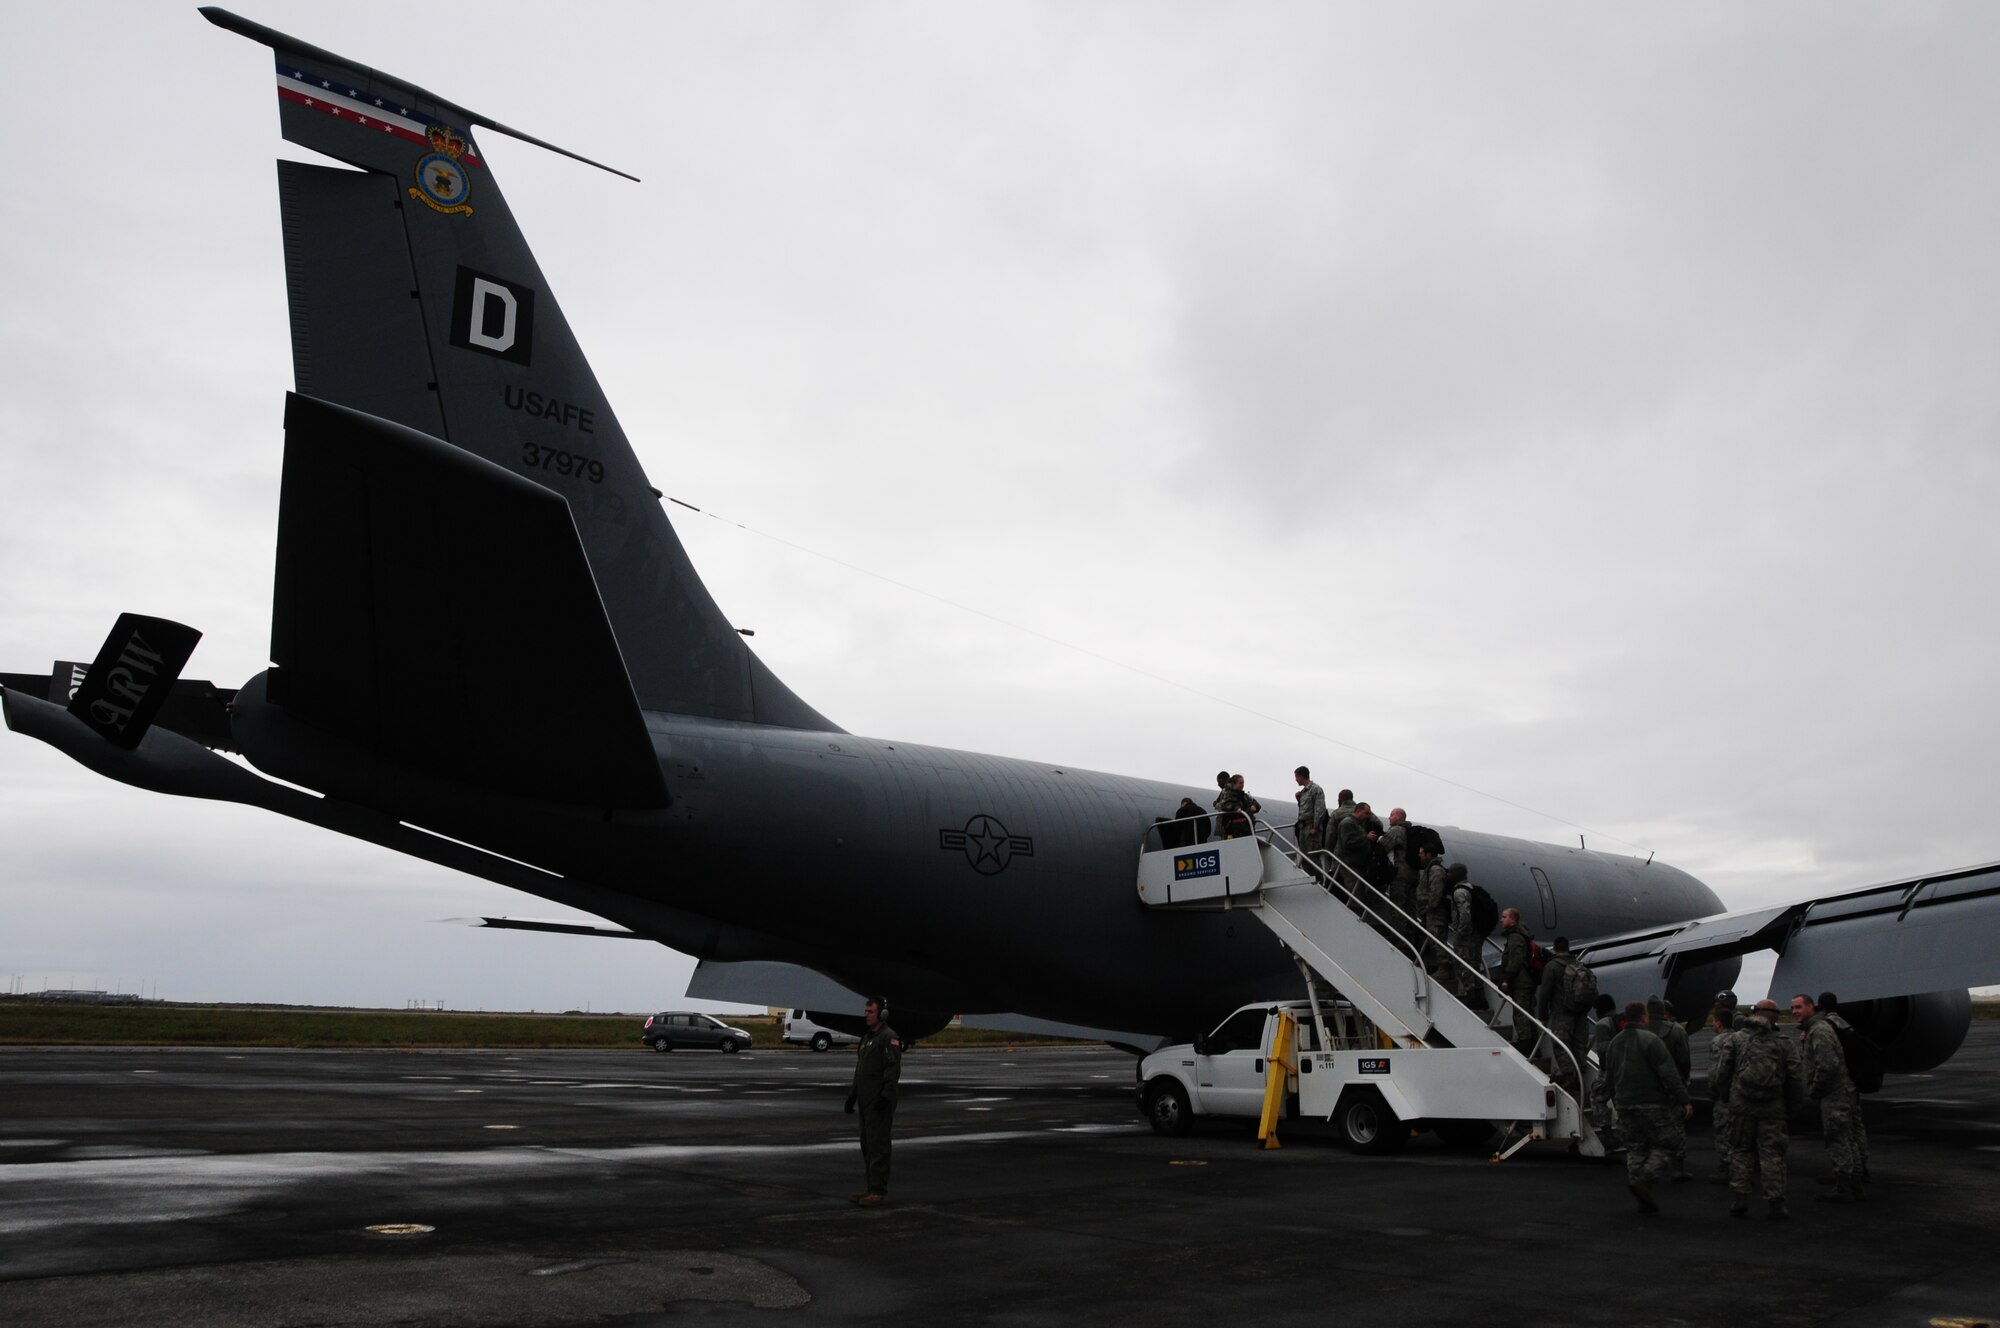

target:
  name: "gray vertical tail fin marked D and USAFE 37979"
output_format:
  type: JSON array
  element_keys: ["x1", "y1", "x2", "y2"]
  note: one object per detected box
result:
[{"x1": 202, "y1": 8, "x2": 838, "y2": 732}]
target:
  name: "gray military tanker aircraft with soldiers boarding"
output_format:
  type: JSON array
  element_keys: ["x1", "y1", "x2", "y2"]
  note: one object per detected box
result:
[{"x1": 0, "y1": 8, "x2": 2000, "y2": 1068}]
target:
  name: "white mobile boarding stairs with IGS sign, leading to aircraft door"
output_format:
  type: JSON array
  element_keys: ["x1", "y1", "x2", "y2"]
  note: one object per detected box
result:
[{"x1": 1138, "y1": 822, "x2": 1604, "y2": 1160}]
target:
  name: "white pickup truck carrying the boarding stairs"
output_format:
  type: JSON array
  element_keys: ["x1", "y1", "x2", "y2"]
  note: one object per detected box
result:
[{"x1": 1138, "y1": 1000, "x2": 1554, "y2": 1152}]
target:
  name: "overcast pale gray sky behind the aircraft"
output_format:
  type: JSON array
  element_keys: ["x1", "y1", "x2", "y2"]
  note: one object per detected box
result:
[{"x1": 0, "y1": 0, "x2": 2000, "y2": 1010}]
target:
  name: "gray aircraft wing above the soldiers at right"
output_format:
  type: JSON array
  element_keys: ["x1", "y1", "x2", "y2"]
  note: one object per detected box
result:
[{"x1": 1580, "y1": 862, "x2": 2000, "y2": 1002}]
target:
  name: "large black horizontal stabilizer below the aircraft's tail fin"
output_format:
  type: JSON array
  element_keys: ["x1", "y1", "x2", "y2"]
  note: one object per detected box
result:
[{"x1": 270, "y1": 394, "x2": 666, "y2": 808}]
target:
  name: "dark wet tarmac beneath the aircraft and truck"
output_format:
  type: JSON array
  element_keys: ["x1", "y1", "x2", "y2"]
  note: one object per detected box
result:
[{"x1": 0, "y1": 1022, "x2": 2000, "y2": 1328}]
